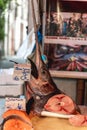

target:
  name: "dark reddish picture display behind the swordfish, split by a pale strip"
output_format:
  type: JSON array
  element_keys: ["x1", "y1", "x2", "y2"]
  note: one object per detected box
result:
[{"x1": 44, "y1": 0, "x2": 87, "y2": 76}]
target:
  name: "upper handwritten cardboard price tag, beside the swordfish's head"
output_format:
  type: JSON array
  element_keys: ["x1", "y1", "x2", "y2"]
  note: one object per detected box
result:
[{"x1": 13, "y1": 64, "x2": 31, "y2": 81}]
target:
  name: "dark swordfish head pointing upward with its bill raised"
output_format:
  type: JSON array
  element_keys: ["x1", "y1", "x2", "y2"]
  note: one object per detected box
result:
[{"x1": 28, "y1": 34, "x2": 61, "y2": 96}]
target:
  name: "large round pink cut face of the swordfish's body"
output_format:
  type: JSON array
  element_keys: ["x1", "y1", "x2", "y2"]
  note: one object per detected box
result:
[{"x1": 44, "y1": 94, "x2": 76, "y2": 114}]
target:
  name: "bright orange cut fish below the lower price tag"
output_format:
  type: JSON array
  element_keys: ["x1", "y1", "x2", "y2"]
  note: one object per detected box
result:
[{"x1": 0, "y1": 109, "x2": 33, "y2": 130}]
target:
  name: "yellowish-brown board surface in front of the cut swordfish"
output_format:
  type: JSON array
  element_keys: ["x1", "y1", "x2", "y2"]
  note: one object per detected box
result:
[{"x1": 31, "y1": 116, "x2": 87, "y2": 130}]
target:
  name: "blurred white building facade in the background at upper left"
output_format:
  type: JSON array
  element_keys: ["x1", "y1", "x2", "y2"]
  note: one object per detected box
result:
[{"x1": 4, "y1": 0, "x2": 28, "y2": 56}]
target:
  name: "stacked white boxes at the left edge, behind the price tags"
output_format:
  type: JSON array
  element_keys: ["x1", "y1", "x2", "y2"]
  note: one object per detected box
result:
[{"x1": 0, "y1": 68, "x2": 23, "y2": 97}]
